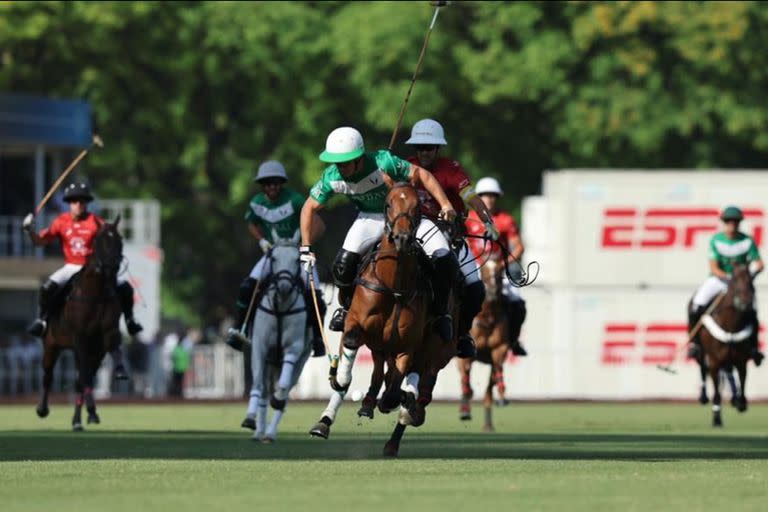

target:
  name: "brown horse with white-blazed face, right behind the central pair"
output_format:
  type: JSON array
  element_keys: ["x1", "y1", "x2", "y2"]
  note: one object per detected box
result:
[{"x1": 457, "y1": 257, "x2": 511, "y2": 432}]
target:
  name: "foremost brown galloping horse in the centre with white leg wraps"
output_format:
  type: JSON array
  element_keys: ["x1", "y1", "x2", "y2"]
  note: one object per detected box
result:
[{"x1": 310, "y1": 182, "x2": 438, "y2": 448}]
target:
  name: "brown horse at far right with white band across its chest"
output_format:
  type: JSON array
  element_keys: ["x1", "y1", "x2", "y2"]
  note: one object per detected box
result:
[{"x1": 699, "y1": 265, "x2": 755, "y2": 427}]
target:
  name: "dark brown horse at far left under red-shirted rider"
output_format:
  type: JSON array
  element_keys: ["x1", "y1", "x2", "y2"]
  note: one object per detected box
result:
[{"x1": 36, "y1": 216, "x2": 123, "y2": 431}]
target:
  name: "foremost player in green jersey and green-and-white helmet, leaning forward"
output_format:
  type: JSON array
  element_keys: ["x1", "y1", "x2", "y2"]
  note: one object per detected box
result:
[{"x1": 300, "y1": 126, "x2": 472, "y2": 351}]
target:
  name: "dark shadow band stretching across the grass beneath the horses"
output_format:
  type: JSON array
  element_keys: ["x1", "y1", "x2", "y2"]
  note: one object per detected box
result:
[{"x1": 0, "y1": 430, "x2": 768, "y2": 462}]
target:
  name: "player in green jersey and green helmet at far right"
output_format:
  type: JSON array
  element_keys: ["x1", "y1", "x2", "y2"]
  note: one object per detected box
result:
[{"x1": 688, "y1": 206, "x2": 764, "y2": 366}]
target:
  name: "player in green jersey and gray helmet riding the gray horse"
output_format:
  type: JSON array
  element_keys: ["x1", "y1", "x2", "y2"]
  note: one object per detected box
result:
[{"x1": 227, "y1": 160, "x2": 325, "y2": 356}]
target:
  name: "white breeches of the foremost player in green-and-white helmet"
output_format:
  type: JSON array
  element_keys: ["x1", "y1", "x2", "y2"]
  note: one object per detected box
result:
[{"x1": 342, "y1": 213, "x2": 450, "y2": 257}]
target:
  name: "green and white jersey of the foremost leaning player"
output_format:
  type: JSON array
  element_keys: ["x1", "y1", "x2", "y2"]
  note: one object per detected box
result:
[{"x1": 309, "y1": 150, "x2": 411, "y2": 213}]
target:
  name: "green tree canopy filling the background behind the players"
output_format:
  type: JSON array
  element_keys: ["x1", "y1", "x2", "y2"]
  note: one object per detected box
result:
[{"x1": 0, "y1": 1, "x2": 768, "y2": 320}]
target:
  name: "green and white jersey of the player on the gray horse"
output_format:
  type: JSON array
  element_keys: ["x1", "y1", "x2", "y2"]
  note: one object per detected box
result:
[{"x1": 245, "y1": 187, "x2": 304, "y2": 243}]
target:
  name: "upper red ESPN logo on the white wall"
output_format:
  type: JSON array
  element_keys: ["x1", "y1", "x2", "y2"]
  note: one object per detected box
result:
[{"x1": 600, "y1": 207, "x2": 765, "y2": 249}]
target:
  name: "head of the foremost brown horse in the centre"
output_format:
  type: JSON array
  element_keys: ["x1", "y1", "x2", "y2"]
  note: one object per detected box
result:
[{"x1": 384, "y1": 183, "x2": 421, "y2": 252}]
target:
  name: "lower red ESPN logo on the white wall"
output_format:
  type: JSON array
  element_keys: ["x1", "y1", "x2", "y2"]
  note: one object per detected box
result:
[{"x1": 600, "y1": 323, "x2": 764, "y2": 366}]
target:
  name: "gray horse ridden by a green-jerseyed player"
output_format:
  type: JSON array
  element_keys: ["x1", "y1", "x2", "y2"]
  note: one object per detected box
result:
[{"x1": 246, "y1": 232, "x2": 312, "y2": 443}]
